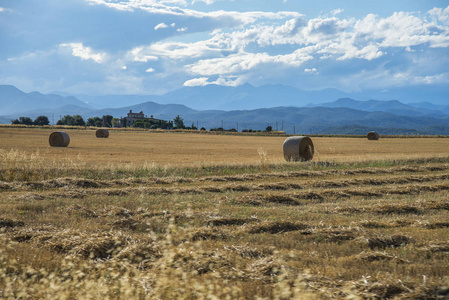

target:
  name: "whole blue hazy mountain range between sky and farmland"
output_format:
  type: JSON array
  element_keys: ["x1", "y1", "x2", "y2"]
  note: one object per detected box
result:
[{"x1": 0, "y1": 84, "x2": 449, "y2": 135}]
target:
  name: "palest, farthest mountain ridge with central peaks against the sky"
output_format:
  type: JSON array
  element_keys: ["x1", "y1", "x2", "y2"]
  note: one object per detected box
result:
[{"x1": 55, "y1": 84, "x2": 349, "y2": 110}]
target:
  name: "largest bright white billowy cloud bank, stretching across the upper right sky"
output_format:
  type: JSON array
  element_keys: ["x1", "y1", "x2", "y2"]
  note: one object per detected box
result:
[{"x1": 130, "y1": 7, "x2": 445, "y2": 84}]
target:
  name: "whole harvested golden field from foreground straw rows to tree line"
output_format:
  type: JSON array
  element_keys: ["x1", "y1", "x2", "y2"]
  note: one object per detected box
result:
[{"x1": 0, "y1": 128, "x2": 449, "y2": 299}]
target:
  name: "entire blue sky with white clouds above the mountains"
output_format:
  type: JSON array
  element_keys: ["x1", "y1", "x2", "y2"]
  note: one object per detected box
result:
[{"x1": 0, "y1": 0, "x2": 449, "y2": 95}]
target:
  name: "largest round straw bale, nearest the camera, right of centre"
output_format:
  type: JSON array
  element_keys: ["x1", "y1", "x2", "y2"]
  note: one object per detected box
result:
[{"x1": 284, "y1": 136, "x2": 315, "y2": 161}]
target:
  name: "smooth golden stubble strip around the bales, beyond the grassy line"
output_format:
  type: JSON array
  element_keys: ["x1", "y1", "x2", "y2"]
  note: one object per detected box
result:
[{"x1": 0, "y1": 127, "x2": 449, "y2": 167}]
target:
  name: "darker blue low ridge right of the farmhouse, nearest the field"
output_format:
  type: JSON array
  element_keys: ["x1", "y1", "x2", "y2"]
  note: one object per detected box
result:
[{"x1": 180, "y1": 107, "x2": 449, "y2": 134}]
